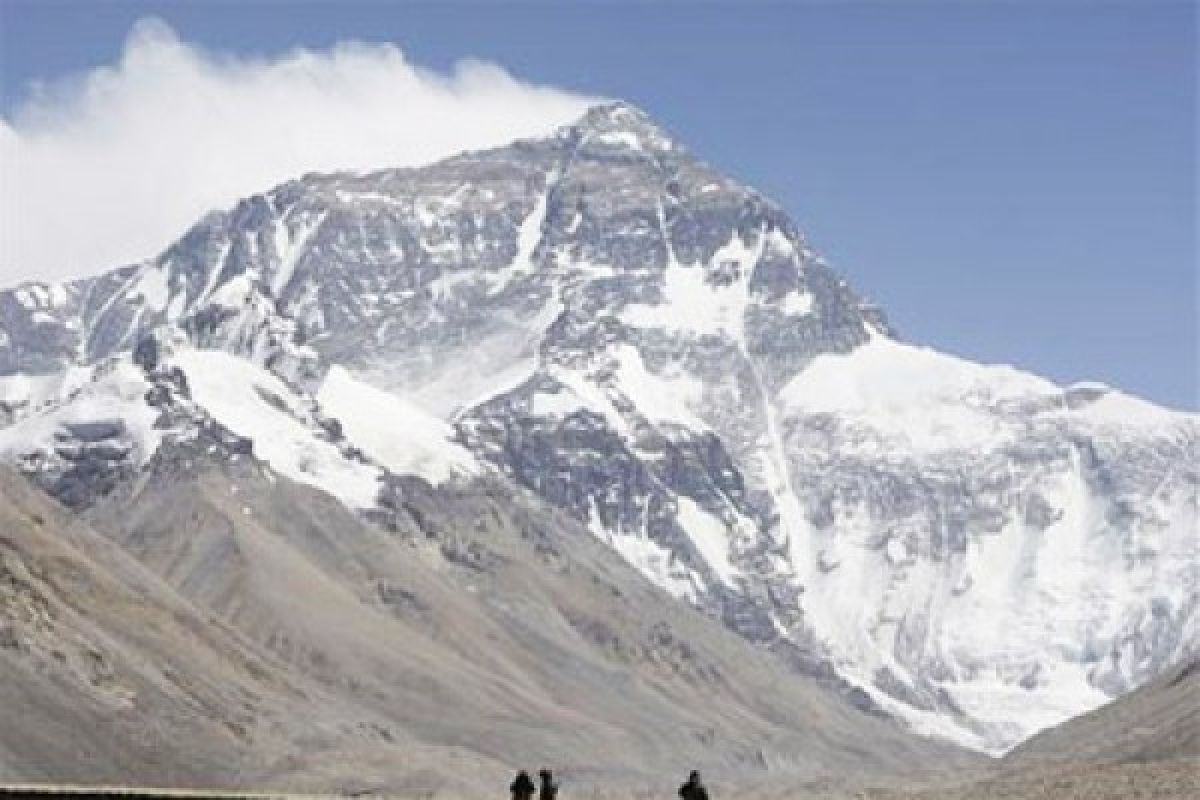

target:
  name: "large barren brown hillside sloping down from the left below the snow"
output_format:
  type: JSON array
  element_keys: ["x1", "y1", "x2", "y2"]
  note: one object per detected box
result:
[{"x1": 0, "y1": 460, "x2": 977, "y2": 796}]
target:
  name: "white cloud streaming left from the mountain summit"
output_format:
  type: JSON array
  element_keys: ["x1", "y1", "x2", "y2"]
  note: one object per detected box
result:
[{"x1": 0, "y1": 19, "x2": 593, "y2": 285}]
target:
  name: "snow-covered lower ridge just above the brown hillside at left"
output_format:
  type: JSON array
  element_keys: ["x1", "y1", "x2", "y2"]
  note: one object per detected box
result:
[{"x1": 0, "y1": 344, "x2": 481, "y2": 511}]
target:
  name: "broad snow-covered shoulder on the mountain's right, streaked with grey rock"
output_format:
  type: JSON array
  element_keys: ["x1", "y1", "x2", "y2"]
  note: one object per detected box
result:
[{"x1": 780, "y1": 338, "x2": 1200, "y2": 747}]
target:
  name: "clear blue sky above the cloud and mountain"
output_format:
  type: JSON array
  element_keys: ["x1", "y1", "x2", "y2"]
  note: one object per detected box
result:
[{"x1": 0, "y1": 0, "x2": 1200, "y2": 409}]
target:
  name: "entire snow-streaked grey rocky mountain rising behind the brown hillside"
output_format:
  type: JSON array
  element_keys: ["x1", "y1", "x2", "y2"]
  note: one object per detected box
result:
[{"x1": 0, "y1": 104, "x2": 1200, "y2": 752}]
